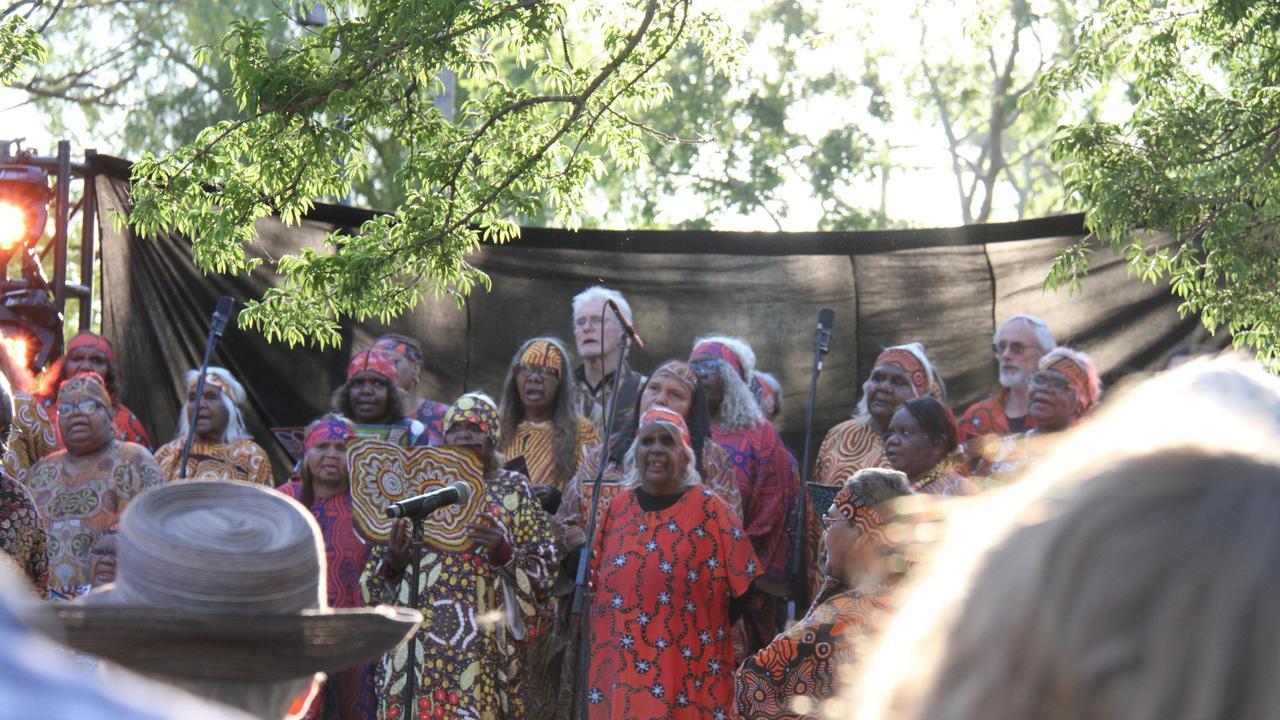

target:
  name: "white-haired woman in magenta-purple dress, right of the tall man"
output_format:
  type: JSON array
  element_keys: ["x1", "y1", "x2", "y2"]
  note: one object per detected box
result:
[{"x1": 689, "y1": 336, "x2": 800, "y2": 652}]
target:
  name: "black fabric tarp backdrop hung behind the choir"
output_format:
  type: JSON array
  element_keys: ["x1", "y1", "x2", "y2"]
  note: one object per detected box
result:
[{"x1": 96, "y1": 156, "x2": 1221, "y2": 478}]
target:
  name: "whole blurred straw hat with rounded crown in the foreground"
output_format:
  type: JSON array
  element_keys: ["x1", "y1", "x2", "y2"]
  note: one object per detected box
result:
[{"x1": 38, "y1": 482, "x2": 422, "y2": 682}]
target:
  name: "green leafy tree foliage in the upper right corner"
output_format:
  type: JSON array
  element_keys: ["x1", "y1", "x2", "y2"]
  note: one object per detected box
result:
[{"x1": 1037, "y1": 0, "x2": 1280, "y2": 360}]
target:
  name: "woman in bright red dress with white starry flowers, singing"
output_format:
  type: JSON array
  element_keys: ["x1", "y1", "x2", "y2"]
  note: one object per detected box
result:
[{"x1": 586, "y1": 406, "x2": 760, "y2": 720}]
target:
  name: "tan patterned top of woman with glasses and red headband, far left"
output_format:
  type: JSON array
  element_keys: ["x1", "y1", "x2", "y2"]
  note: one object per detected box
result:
[{"x1": 24, "y1": 439, "x2": 164, "y2": 600}]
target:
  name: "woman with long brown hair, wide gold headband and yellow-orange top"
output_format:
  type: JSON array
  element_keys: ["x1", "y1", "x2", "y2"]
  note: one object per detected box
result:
[{"x1": 499, "y1": 337, "x2": 600, "y2": 491}]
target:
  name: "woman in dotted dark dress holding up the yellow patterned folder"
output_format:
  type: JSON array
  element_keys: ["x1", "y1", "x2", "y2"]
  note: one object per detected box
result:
[{"x1": 361, "y1": 393, "x2": 556, "y2": 717}]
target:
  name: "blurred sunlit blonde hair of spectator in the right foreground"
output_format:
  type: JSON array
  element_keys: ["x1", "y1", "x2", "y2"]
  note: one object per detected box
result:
[{"x1": 846, "y1": 361, "x2": 1280, "y2": 720}]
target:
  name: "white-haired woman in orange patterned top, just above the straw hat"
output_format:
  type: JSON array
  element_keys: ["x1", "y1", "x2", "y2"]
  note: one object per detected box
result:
[{"x1": 156, "y1": 366, "x2": 275, "y2": 487}]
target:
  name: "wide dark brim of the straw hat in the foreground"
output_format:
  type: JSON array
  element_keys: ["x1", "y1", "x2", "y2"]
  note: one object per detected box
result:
[{"x1": 35, "y1": 603, "x2": 422, "y2": 682}]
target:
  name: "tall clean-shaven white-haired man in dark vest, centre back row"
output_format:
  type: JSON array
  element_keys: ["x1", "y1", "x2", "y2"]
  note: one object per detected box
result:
[{"x1": 573, "y1": 286, "x2": 648, "y2": 464}]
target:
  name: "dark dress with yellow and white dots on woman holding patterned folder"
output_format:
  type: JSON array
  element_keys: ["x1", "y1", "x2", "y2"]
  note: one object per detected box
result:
[{"x1": 360, "y1": 470, "x2": 557, "y2": 720}]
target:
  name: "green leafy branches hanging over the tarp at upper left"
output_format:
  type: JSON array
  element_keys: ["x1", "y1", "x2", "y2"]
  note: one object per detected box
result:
[{"x1": 129, "y1": 0, "x2": 733, "y2": 345}]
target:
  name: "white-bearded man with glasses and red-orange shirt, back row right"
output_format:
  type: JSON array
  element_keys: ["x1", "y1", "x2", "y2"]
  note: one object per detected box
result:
[{"x1": 959, "y1": 315, "x2": 1057, "y2": 442}]
